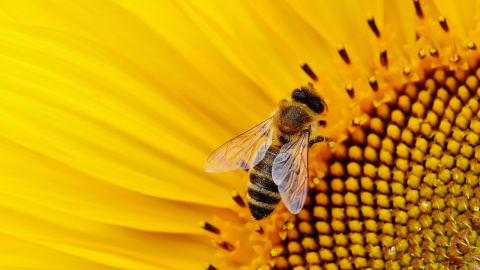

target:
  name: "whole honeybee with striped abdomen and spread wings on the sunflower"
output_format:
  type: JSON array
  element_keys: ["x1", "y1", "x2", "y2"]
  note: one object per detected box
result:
[{"x1": 205, "y1": 83, "x2": 332, "y2": 220}]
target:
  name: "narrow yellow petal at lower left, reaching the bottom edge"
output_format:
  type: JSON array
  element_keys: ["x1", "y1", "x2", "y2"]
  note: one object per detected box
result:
[{"x1": 0, "y1": 190, "x2": 216, "y2": 269}]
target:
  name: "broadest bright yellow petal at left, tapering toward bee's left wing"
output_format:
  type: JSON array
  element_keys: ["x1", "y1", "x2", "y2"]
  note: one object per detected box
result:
[{"x1": 0, "y1": 24, "x2": 246, "y2": 205}]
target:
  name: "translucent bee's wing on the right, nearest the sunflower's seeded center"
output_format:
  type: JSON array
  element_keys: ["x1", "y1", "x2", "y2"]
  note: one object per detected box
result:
[{"x1": 272, "y1": 131, "x2": 310, "y2": 215}]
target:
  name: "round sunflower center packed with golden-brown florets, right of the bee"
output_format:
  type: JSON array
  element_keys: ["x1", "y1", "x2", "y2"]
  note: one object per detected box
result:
[{"x1": 276, "y1": 69, "x2": 480, "y2": 269}]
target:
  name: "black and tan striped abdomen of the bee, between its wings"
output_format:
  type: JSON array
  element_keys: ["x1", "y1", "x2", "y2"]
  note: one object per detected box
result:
[{"x1": 247, "y1": 145, "x2": 281, "y2": 220}]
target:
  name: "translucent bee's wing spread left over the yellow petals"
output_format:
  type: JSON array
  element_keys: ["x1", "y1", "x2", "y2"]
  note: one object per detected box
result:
[{"x1": 205, "y1": 118, "x2": 273, "y2": 172}]
